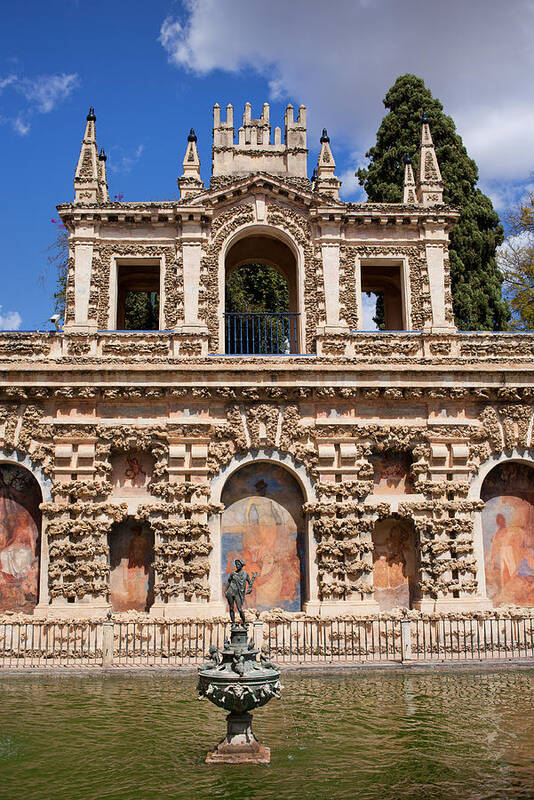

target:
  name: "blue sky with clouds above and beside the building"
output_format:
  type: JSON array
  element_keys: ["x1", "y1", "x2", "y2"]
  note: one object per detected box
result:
[{"x1": 0, "y1": 0, "x2": 534, "y2": 330}]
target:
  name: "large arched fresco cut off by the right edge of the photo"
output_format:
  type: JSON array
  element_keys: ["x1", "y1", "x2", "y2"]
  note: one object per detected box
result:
[{"x1": 481, "y1": 463, "x2": 534, "y2": 606}]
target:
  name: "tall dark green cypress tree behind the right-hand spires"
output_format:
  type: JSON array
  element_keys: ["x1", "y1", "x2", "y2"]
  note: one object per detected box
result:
[{"x1": 357, "y1": 75, "x2": 510, "y2": 330}]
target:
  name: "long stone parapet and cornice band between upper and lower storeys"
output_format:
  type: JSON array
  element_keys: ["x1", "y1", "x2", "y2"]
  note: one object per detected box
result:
[{"x1": 0, "y1": 331, "x2": 534, "y2": 390}]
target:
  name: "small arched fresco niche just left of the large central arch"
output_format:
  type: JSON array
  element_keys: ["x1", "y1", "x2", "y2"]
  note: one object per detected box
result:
[{"x1": 109, "y1": 519, "x2": 154, "y2": 611}]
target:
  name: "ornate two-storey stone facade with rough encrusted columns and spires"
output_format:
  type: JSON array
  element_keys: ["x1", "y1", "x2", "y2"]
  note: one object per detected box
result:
[{"x1": 0, "y1": 107, "x2": 534, "y2": 618}]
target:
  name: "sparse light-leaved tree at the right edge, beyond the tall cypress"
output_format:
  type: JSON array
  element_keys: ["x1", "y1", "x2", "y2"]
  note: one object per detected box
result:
[{"x1": 499, "y1": 193, "x2": 534, "y2": 331}]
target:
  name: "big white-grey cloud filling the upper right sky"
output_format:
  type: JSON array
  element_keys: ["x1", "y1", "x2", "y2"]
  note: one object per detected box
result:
[{"x1": 159, "y1": 0, "x2": 534, "y2": 197}]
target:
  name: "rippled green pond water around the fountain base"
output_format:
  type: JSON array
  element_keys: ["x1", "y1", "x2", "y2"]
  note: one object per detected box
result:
[{"x1": 0, "y1": 670, "x2": 534, "y2": 800}]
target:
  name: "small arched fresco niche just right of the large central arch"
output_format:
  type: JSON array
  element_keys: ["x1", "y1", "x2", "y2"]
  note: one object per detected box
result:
[{"x1": 373, "y1": 519, "x2": 418, "y2": 611}]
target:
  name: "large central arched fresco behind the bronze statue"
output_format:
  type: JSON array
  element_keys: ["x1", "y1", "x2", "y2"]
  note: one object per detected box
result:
[{"x1": 222, "y1": 462, "x2": 305, "y2": 611}]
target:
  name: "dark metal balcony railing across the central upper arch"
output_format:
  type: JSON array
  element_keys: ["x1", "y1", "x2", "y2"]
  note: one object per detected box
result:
[{"x1": 224, "y1": 313, "x2": 299, "y2": 356}]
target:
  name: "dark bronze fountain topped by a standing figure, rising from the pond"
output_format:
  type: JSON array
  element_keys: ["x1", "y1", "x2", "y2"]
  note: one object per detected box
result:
[{"x1": 197, "y1": 559, "x2": 282, "y2": 764}]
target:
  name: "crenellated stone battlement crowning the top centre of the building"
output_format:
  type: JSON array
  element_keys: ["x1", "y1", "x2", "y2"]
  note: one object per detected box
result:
[{"x1": 212, "y1": 103, "x2": 308, "y2": 178}]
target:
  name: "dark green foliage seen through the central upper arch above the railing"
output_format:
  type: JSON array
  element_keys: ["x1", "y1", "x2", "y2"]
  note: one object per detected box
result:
[{"x1": 225, "y1": 264, "x2": 289, "y2": 313}]
